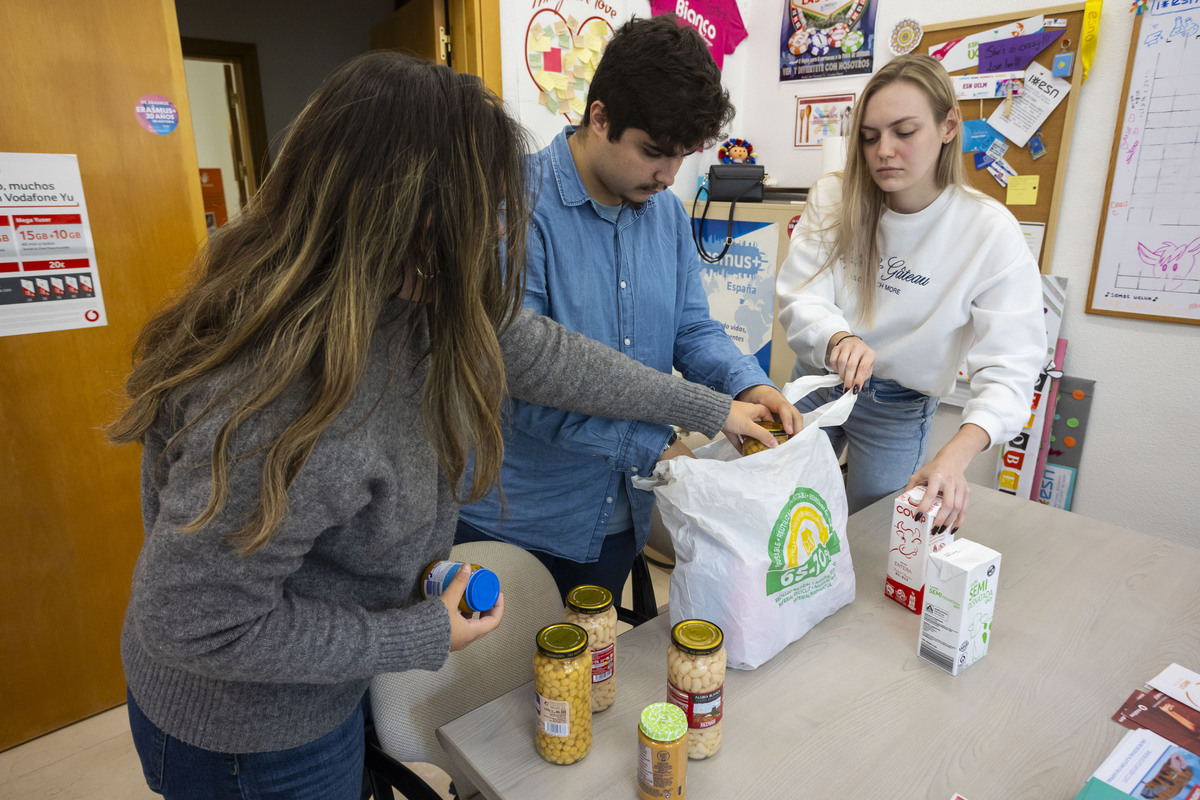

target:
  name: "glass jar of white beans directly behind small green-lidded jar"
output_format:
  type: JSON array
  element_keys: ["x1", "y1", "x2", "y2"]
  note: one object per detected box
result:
[{"x1": 667, "y1": 619, "x2": 725, "y2": 758}]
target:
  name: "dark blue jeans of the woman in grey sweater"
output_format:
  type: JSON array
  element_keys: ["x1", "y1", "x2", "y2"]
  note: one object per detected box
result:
[{"x1": 126, "y1": 692, "x2": 364, "y2": 800}]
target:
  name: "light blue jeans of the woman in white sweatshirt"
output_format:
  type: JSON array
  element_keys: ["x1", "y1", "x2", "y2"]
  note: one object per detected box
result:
[{"x1": 796, "y1": 378, "x2": 937, "y2": 513}]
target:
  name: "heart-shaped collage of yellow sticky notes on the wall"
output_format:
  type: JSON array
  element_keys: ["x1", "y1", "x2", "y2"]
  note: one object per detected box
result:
[{"x1": 526, "y1": 8, "x2": 613, "y2": 125}]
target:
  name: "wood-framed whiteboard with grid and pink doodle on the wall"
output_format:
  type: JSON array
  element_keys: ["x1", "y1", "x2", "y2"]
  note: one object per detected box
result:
[{"x1": 1087, "y1": 2, "x2": 1200, "y2": 325}]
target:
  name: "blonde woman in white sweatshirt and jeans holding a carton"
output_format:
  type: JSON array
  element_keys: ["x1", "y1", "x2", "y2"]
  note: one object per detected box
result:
[{"x1": 778, "y1": 54, "x2": 1046, "y2": 530}]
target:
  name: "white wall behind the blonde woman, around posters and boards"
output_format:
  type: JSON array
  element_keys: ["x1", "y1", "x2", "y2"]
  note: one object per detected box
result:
[{"x1": 676, "y1": 0, "x2": 1200, "y2": 547}]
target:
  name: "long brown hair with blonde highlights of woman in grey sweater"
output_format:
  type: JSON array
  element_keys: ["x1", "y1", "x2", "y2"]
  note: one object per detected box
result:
[{"x1": 108, "y1": 52, "x2": 528, "y2": 554}]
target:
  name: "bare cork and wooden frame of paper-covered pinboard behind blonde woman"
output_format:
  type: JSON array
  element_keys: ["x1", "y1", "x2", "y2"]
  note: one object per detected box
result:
[{"x1": 917, "y1": 2, "x2": 1084, "y2": 273}]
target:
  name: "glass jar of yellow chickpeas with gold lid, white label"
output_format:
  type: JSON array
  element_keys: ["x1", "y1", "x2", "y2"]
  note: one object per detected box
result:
[{"x1": 533, "y1": 622, "x2": 592, "y2": 764}]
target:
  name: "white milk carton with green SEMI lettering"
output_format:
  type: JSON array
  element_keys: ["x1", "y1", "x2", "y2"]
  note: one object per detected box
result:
[{"x1": 917, "y1": 539, "x2": 1000, "y2": 675}]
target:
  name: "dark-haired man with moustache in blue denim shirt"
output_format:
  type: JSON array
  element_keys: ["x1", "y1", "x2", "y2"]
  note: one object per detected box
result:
[{"x1": 455, "y1": 14, "x2": 802, "y2": 600}]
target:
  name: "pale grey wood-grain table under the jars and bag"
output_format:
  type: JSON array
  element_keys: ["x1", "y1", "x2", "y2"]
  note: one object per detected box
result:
[{"x1": 438, "y1": 486, "x2": 1200, "y2": 800}]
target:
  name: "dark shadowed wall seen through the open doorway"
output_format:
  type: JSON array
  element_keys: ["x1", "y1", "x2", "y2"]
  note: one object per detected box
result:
[{"x1": 175, "y1": 0, "x2": 396, "y2": 160}]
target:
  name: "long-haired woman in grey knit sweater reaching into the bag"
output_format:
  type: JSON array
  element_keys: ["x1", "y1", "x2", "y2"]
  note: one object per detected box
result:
[{"x1": 110, "y1": 53, "x2": 770, "y2": 800}]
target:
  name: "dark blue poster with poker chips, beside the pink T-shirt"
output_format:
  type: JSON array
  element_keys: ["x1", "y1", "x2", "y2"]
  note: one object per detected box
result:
[{"x1": 779, "y1": 0, "x2": 875, "y2": 80}]
